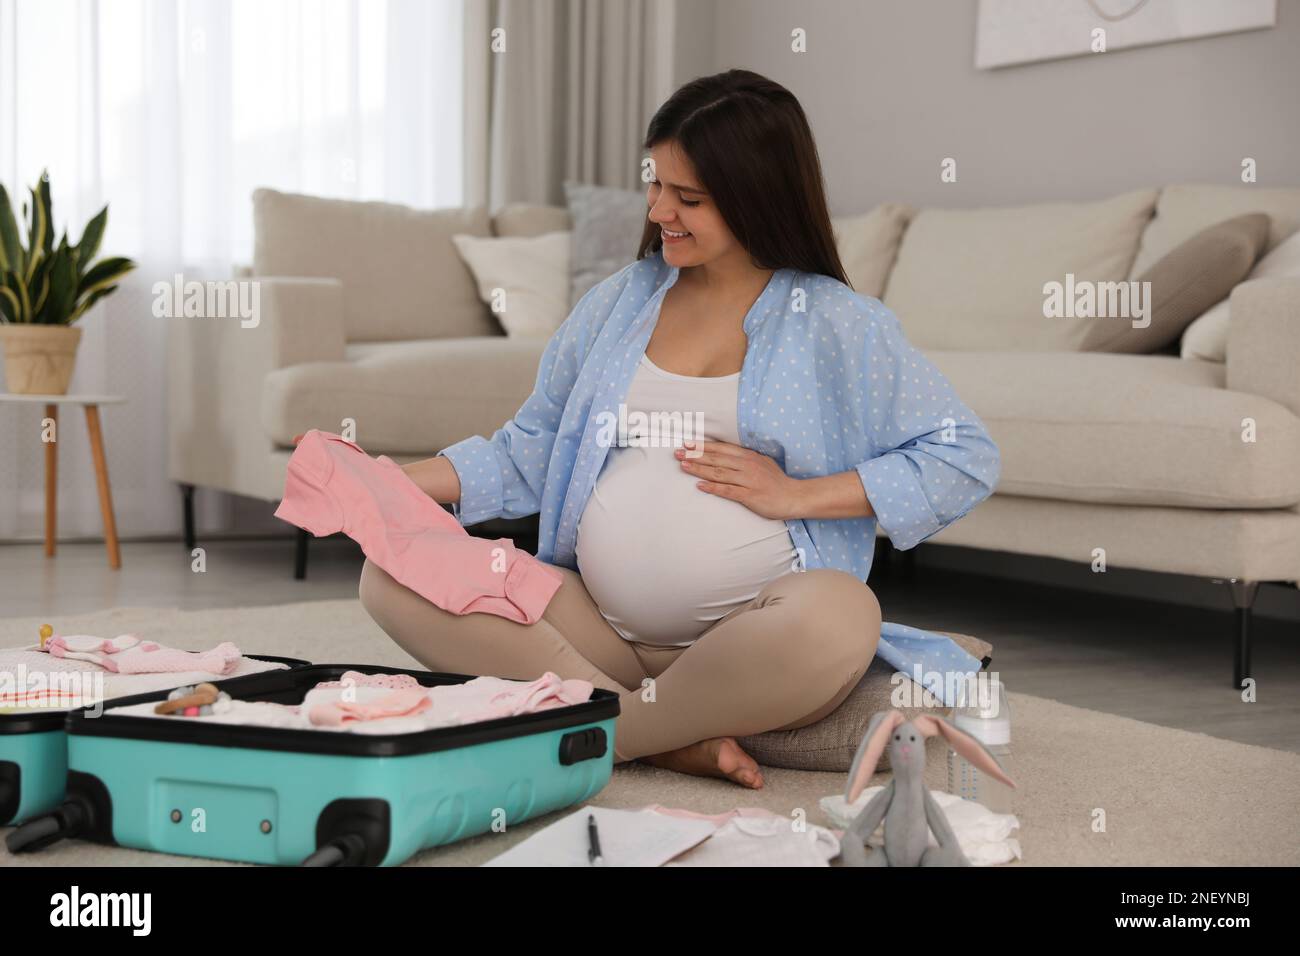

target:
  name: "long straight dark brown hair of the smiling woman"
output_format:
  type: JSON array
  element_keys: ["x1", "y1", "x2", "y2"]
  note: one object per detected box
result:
[{"x1": 637, "y1": 70, "x2": 849, "y2": 285}]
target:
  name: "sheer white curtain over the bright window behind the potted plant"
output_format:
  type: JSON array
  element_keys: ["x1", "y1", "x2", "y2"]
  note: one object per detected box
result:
[{"x1": 0, "y1": 0, "x2": 464, "y2": 540}]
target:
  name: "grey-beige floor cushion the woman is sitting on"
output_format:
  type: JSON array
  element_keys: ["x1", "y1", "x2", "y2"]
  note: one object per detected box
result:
[{"x1": 736, "y1": 631, "x2": 993, "y2": 773}]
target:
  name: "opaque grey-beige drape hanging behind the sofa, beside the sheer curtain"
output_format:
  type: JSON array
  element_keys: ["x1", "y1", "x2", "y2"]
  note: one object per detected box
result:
[{"x1": 464, "y1": 0, "x2": 686, "y2": 209}]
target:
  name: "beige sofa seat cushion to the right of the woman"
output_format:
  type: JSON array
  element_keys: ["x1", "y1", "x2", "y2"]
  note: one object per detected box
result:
[{"x1": 927, "y1": 350, "x2": 1300, "y2": 509}]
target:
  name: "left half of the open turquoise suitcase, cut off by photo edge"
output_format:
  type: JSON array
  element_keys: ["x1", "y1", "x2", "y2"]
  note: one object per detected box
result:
[{"x1": 0, "y1": 654, "x2": 311, "y2": 826}]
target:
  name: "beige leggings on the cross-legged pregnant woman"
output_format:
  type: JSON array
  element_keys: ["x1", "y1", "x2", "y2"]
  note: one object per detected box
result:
[{"x1": 360, "y1": 561, "x2": 880, "y2": 761}]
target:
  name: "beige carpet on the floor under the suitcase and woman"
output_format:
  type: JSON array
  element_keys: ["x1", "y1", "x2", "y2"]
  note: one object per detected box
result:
[{"x1": 0, "y1": 600, "x2": 1300, "y2": 866}]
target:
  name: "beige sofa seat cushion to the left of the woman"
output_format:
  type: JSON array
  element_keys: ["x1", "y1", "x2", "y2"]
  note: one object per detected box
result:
[{"x1": 261, "y1": 336, "x2": 546, "y2": 455}]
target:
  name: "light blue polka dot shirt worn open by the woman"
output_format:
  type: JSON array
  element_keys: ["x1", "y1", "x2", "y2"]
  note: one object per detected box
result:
[{"x1": 439, "y1": 254, "x2": 1001, "y2": 704}]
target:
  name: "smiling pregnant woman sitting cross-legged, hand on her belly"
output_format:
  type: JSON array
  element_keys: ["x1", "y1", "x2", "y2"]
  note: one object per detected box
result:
[{"x1": 360, "y1": 70, "x2": 998, "y2": 787}]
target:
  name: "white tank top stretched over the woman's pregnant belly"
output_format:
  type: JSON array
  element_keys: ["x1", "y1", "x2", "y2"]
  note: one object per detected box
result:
[{"x1": 575, "y1": 356, "x2": 796, "y2": 646}]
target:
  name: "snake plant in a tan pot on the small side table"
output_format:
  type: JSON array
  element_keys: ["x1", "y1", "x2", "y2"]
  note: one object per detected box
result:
[{"x1": 0, "y1": 173, "x2": 135, "y2": 395}]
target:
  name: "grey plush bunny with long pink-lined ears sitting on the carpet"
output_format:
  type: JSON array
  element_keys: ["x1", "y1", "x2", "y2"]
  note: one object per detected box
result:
[{"x1": 840, "y1": 710, "x2": 1015, "y2": 866}]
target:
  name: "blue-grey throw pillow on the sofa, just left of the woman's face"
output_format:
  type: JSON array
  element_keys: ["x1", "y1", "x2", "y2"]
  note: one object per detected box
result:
[{"x1": 564, "y1": 179, "x2": 649, "y2": 308}]
